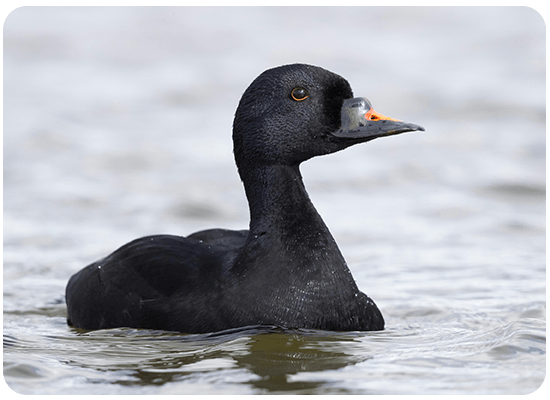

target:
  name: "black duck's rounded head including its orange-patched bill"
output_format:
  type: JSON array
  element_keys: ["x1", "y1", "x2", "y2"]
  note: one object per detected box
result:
[{"x1": 233, "y1": 64, "x2": 424, "y2": 171}]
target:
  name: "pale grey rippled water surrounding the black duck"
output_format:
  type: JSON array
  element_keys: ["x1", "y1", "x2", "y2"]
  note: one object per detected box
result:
[{"x1": 3, "y1": 7, "x2": 546, "y2": 394}]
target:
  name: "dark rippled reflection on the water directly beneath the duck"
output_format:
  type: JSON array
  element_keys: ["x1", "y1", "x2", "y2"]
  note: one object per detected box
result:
[{"x1": 57, "y1": 326, "x2": 376, "y2": 392}]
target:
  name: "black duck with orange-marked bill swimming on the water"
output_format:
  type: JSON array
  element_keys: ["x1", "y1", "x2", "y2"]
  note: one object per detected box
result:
[{"x1": 65, "y1": 64, "x2": 424, "y2": 334}]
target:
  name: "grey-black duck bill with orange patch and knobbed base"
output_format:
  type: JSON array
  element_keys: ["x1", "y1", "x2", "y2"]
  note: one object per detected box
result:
[{"x1": 332, "y1": 97, "x2": 424, "y2": 142}]
